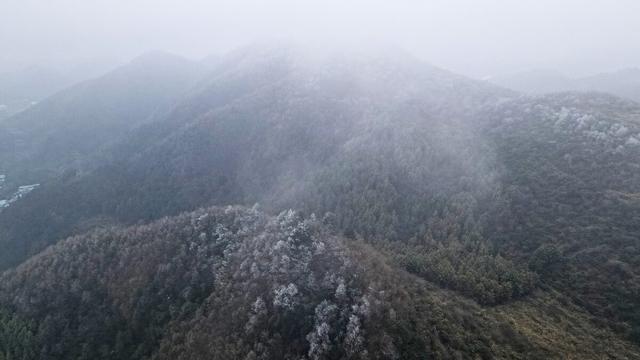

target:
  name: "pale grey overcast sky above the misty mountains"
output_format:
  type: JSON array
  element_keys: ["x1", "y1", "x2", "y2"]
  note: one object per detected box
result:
[{"x1": 0, "y1": 0, "x2": 640, "y2": 77}]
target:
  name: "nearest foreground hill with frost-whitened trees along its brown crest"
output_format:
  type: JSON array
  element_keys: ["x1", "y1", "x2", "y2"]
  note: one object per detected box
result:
[{"x1": 0, "y1": 207, "x2": 638, "y2": 359}]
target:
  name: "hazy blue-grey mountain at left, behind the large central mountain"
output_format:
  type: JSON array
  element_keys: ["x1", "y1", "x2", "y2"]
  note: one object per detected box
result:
[{"x1": 0, "y1": 52, "x2": 202, "y2": 191}]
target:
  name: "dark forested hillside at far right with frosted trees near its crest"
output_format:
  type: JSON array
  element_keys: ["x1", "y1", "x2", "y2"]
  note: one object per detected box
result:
[{"x1": 482, "y1": 93, "x2": 640, "y2": 341}]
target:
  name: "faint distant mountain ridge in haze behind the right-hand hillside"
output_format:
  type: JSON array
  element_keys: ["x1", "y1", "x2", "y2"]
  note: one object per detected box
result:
[{"x1": 489, "y1": 68, "x2": 640, "y2": 102}]
